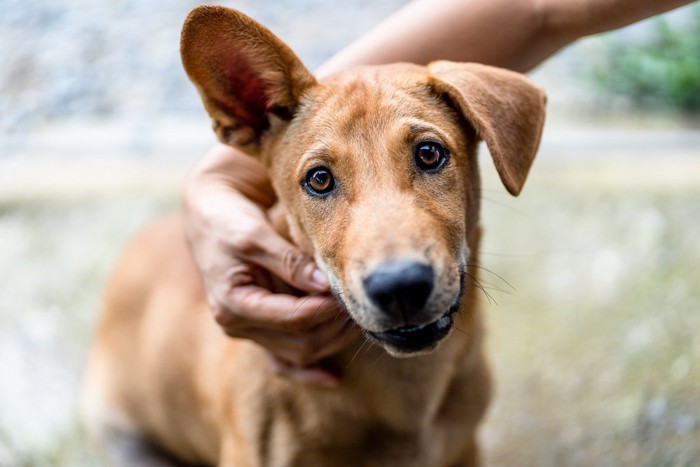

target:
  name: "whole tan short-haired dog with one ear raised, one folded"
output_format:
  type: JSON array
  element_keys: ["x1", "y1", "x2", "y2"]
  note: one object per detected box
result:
[{"x1": 85, "y1": 6, "x2": 545, "y2": 467}]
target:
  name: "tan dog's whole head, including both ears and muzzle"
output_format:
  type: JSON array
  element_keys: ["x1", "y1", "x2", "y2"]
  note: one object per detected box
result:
[{"x1": 181, "y1": 6, "x2": 545, "y2": 355}]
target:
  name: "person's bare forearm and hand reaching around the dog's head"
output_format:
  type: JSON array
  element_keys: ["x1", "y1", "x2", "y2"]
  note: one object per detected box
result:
[{"x1": 183, "y1": 0, "x2": 691, "y2": 386}]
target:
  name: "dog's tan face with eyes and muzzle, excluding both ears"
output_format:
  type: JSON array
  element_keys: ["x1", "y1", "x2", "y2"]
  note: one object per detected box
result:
[{"x1": 271, "y1": 69, "x2": 478, "y2": 352}]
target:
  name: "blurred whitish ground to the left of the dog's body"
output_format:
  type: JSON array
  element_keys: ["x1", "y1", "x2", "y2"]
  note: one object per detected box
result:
[{"x1": 0, "y1": 193, "x2": 177, "y2": 467}]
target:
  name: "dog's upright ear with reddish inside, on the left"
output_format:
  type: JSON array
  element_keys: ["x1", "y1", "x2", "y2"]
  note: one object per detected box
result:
[{"x1": 180, "y1": 6, "x2": 315, "y2": 153}]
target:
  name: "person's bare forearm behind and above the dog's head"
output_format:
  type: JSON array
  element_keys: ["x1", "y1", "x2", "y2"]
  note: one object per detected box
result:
[{"x1": 318, "y1": 0, "x2": 691, "y2": 76}]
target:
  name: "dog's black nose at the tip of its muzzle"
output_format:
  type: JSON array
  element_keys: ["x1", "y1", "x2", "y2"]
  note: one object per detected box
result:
[{"x1": 363, "y1": 260, "x2": 435, "y2": 318}]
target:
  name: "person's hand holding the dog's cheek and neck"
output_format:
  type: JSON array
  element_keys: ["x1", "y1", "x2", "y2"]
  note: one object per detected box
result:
[{"x1": 183, "y1": 145, "x2": 359, "y2": 386}]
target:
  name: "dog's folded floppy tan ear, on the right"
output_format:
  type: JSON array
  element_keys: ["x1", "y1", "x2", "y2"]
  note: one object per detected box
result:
[{"x1": 428, "y1": 61, "x2": 546, "y2": 196}]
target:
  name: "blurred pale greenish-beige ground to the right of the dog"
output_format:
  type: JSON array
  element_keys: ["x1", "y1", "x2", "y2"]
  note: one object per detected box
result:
[{"x1": 483, "y1": 188, "x2": 700, "y2": 467}]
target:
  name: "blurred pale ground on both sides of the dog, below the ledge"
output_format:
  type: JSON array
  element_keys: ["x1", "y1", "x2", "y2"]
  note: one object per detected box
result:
[{"x1": 0, "y1": 155, "x2": 700, "y2": 467}]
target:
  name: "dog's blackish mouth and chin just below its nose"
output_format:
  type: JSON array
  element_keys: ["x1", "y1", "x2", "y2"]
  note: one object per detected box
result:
[{"x1": 368, "y1": 311, "x2": 454, "y2": 357}]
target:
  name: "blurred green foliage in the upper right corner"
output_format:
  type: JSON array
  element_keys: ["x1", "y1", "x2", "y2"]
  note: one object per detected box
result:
[{"x1": 591, "y1": 5, "x2": 700, "y2": 113}]
